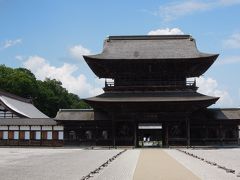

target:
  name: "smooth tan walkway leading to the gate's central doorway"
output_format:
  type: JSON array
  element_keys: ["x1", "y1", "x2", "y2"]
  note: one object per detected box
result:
[{"x1": 133, "y1": 149, "x2": 199, "y2": 180}]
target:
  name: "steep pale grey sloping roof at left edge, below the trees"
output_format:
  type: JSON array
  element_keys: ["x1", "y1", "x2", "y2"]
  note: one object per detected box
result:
[{"x1": 0, "y1": 91, "x2": 49, "y2": 118}]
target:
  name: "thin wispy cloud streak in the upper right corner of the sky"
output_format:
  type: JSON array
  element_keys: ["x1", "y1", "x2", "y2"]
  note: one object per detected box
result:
[{"x1": 157, "y1": 0, "x2": 240, "y2": 21}]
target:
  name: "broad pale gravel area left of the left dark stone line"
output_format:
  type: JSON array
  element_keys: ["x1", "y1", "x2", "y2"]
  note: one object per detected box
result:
[{"x1": 0, "y1": 148, "x2": 121, "y2": 180}]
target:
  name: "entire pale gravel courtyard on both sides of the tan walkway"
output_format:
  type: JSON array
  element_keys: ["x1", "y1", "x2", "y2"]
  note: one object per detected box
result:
[{"x1": 0, "y1": 148, "x2": 240, "y2": 180}]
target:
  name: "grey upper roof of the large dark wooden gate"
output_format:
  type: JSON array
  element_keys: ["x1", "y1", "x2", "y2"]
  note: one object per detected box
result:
[{"x1": 84, "y1": 35, "x2": 217, "y2": 60}]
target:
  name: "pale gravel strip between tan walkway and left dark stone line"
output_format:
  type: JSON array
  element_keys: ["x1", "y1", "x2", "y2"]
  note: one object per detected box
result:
[{"x1": 93, "y1": 150, "x2": 140, "y2": 180}]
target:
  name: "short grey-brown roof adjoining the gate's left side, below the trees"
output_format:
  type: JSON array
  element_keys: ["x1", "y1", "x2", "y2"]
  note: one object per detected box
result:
[{"x1": 55, "y1": 109, "x2": 94, "y2": 120}]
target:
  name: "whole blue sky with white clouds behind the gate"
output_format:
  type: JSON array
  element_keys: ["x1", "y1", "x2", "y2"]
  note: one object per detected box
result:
[{"x1": 0, "y1": 0, "x2": 240, "y2": 107}]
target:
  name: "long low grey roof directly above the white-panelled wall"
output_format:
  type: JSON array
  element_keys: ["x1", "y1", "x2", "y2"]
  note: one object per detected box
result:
[{"x1": 0, "y1": 118, "x2": 57, "y2": 126}]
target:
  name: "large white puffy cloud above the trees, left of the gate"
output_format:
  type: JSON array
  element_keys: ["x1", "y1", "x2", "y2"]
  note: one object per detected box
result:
[{"x1": 23, "y1": 56, "x2": 103, "y2": 98}]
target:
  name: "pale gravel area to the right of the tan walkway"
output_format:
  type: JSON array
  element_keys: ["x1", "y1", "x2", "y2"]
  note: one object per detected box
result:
[{"x1": 164, "y1": 149, "x2": 240, "y2": 180}]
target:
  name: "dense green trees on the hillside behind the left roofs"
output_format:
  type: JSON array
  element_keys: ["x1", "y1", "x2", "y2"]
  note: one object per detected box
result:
[{"x1": 0, "y1": 65, "x2": 90, "y2": 117}]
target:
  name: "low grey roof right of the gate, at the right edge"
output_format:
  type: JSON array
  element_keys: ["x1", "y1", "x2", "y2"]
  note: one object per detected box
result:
[{"x1": 209, "y1": 108, "x2": 240, "y2": 120}]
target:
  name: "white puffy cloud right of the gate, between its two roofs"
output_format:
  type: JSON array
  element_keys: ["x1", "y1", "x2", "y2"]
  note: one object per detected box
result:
[{"x1": 196, "y1": 77, "x2": 233, "y2": 107}]
